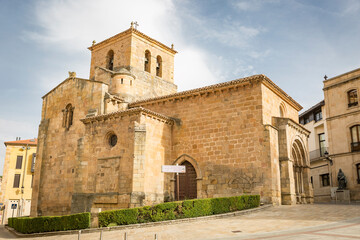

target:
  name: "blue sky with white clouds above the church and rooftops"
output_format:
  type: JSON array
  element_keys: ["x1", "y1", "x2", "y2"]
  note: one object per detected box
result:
[{"x1": 0, "y1": 0, "x2": 360, "y2": 175}]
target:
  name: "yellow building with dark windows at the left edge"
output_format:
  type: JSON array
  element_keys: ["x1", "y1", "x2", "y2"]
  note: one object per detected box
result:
[{"x1": 0, "y1": 139, "x2": 37, "y2": 224}]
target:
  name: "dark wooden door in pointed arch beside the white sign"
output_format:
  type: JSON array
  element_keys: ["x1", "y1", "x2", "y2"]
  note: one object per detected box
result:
[{"x1": 175, "y1": 161, "x2": 197, "y2": 200}]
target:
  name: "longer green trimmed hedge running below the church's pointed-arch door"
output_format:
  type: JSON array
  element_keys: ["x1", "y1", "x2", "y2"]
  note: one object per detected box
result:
[{"x1": 99, "y1": 195, "x2": 260, "y2": 227}]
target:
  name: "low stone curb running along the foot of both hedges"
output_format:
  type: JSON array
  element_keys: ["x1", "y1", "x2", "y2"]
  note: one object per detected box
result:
[{"x1": 5, "y1": 204, "x2": 273, "y2": 238}]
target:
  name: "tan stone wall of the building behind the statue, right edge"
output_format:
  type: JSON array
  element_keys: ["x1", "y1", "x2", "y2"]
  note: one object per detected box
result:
[{"x1": 324, "y1": 69, "x2": 360, "y2": 200}]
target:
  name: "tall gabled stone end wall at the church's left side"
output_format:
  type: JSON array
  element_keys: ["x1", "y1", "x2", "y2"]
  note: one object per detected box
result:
[{"x1": 31, "y1": 78, "x2": 107, "y2": 216}]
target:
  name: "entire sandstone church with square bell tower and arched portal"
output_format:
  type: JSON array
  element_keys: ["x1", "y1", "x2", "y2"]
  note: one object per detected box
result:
[{"x1": 31, "y1": 27, "x2": 312, "y2": 216}]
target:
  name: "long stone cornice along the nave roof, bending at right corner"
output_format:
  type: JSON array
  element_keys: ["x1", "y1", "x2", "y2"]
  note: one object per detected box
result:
[{"x1": 129, "y1": 74, "x2": 302, "y2": 111}]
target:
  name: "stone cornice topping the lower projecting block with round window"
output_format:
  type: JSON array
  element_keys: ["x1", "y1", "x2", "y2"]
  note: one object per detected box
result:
[{"x1": 80, "y1": 107, "x2": 174, "y2": 125}]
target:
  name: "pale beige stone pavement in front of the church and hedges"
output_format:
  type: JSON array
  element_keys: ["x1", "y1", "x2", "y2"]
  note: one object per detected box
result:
[{"x1": 0, "y1": 204, "x2": 360, "y2": 240}]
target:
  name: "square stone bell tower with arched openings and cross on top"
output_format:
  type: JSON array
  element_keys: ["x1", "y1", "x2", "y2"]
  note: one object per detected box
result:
[{"x1": 88, "y1": 23, "x2": 177, "y2": 102}]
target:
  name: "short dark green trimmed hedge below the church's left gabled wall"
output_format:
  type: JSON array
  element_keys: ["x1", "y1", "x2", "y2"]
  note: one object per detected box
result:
[{"x1": 8, "y1": 213, "x2": 91, "y2": 233}]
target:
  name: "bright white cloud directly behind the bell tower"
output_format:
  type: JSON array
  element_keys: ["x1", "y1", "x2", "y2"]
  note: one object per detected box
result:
[{"x1": 26, "y1": 0, "x2": 216, "y2": 91}]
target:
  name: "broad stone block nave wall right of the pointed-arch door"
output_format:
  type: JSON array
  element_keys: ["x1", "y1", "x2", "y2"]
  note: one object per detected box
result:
[{"x1": 131, "y1": 81, "x2": 272, "y2": 202}]
